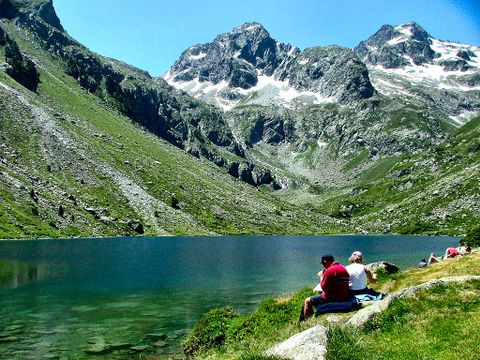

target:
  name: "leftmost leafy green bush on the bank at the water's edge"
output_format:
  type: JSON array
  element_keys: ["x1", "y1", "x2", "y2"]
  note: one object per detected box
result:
[{"x1": 182, "y1": 307, "x2": 240, "y2": 356}]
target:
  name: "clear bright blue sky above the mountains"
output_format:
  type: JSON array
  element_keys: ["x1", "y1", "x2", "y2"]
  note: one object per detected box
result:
[{"x1": 54, "y1": 0, "x2": 480, "y2": 76}]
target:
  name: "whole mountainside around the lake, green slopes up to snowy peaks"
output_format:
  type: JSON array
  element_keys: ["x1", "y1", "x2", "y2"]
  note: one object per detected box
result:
[{"x1": 0, "y1": 0, "x2": 480, "y2": 238}]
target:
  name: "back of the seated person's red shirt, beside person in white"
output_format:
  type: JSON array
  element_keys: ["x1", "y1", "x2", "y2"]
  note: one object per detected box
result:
[{"x1": 322, "y1": 262, "x2": 350, "y2": 301}]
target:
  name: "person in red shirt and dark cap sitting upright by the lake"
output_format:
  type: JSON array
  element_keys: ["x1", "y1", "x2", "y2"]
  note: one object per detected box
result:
[{"x1": 301, "y1": 255, "x2": 350, "y2": 320}]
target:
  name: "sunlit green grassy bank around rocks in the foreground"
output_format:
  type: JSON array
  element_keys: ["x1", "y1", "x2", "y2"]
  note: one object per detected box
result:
[{"x1": 184, "y1": 252, "x2": 480, "y2": 360}]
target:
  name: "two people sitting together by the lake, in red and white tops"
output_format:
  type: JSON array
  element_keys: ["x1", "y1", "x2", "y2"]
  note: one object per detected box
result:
[{"x1": 300, "y1": 251, "x2": 383, "y2": 321}]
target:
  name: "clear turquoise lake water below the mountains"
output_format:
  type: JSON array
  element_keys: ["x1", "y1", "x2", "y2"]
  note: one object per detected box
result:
[{"x1": 0, "y1": 235, "x2": 458, "y2": 359}]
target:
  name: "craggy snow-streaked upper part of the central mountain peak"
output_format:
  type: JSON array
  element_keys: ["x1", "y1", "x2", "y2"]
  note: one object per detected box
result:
[{"x1": 163, "y1": 23, "x2": 375, "y2": 110}]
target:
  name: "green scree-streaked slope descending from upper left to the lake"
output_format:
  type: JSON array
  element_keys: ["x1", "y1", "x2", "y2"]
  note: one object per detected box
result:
[{"x1": 0, "y1": 0, "x2": 345, "y2": 238}]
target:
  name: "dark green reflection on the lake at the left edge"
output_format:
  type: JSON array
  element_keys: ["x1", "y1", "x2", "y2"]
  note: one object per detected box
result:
[{"x1": 0, "y1": 260, "x2": 48, "y2": 290}]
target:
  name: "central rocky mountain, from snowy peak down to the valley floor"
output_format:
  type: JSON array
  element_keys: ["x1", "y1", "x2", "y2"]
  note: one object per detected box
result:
[{"x1": 164, "y1": 23, "x2": 464, "y2": 188}]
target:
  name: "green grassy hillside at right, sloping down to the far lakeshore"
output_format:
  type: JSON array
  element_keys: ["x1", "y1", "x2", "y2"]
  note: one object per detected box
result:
[{"x1": 279, "y1": 117, "x2": 480, "y2": 234}]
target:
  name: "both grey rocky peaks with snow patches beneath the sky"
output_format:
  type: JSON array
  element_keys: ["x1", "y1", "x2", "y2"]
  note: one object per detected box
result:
[{"x1": 163, "y1": 22, "x2": 480, "y2": 126}]
